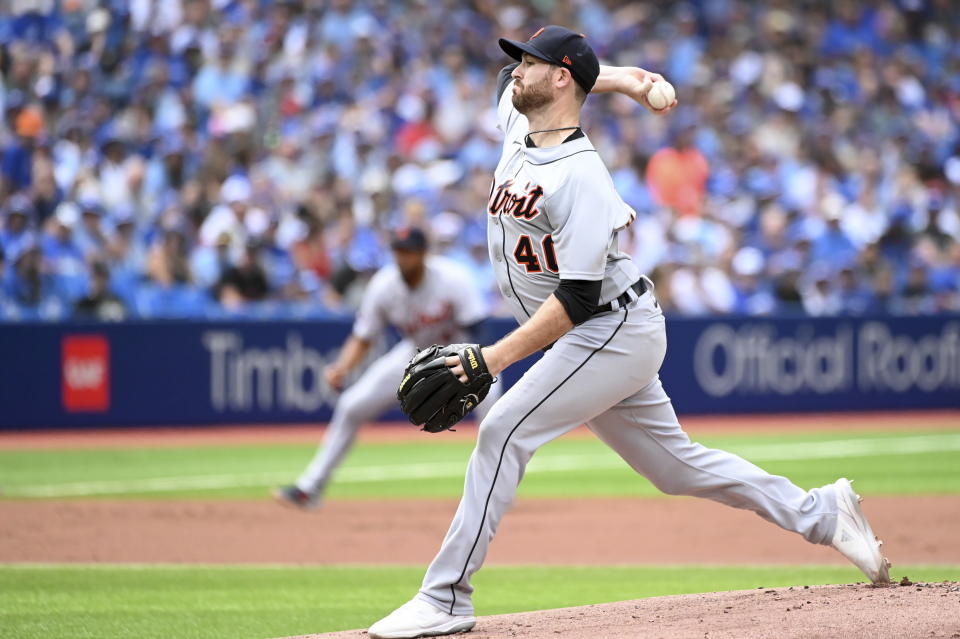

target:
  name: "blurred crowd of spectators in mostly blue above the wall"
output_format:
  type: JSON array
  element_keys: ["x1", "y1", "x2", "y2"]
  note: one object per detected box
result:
[{"x1": 0, "y1": 0, "x2": 960, "y2": 320}]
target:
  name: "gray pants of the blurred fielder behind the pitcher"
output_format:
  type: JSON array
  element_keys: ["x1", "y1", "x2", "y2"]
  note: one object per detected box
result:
[{"x1": 297, "y1": 339, "x2": 503, "y2": 494}]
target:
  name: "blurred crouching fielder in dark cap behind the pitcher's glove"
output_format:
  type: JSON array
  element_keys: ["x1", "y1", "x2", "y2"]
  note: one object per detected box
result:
[{"x1": 273, "y1": 228, "x2": 500, "y2": 509}]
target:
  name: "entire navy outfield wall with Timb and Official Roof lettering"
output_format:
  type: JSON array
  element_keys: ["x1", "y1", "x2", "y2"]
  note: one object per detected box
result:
[{"x1": 0, "y1": 316, "x2": 960, "y2": 428}]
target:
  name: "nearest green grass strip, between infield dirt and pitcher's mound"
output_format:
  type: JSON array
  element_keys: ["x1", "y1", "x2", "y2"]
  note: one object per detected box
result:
[{"x1": 0, "y1": 565, "x2": 960, "y2": 639}]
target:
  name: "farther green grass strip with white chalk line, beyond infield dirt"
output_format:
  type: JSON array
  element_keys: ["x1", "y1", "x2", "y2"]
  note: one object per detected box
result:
[{"x1": 0, "y1": 429, "x2": 960, "y2": 499}]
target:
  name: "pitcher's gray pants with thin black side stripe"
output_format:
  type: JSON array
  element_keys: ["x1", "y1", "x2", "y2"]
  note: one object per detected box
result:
[{"x1": 417, "y1": 292, "x2": 837, "y2": 615}]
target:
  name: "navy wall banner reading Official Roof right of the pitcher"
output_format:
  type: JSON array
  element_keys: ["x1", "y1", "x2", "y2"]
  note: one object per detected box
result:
[{"x1": 661, "y1": 317, "x2": 960, "y2": 413}]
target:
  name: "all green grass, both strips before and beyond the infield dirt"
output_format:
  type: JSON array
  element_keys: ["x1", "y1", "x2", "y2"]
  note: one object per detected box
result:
[{"x1": 0, "y1": 425, "x2": 960, "y2": 639}]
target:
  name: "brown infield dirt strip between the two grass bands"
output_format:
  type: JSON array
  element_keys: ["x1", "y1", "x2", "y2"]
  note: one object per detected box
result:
[{"x1": 0, "y1": 495, "x2": 960, "y2": 564}]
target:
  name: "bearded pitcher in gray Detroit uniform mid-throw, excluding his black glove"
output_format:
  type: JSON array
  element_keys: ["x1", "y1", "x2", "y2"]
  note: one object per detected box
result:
[{"x1": 369, "y1": 26, "x2": 889, "y2": 638}]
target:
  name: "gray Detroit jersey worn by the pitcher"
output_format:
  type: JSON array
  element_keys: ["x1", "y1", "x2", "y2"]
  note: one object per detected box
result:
[{"x1": 487, "y1": 83, "x2": 640, "y2": 323}]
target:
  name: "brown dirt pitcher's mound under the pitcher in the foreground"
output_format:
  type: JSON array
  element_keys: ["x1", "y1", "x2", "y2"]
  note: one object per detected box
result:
[{"x1": 288, "y1": 579, "x2": 960, "y2": 639}]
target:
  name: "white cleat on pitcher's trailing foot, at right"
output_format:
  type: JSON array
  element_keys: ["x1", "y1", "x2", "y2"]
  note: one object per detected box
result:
[{"x1": 831, "y1": 478, "x2": 890, "y2": 584}]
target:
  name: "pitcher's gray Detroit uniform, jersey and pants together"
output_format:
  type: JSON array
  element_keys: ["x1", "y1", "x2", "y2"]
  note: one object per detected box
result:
[{"x1": 408, "y1": 72, "x2": 837, "y2": 615}]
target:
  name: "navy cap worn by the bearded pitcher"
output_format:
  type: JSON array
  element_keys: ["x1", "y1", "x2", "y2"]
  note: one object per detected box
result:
[{"x1": 499, "y1": 24, "x2": 600, "y2": 93}]
